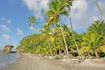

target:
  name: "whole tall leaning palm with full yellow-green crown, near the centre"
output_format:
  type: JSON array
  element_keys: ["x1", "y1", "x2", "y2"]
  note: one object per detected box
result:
[{"x1": 44, "y1": 0, "x2": 69, "y2": 54}]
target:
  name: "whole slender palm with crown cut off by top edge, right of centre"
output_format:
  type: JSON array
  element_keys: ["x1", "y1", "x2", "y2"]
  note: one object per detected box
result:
[{"x1": 66, "y1": 0, "x2": 79, "y2": 51}]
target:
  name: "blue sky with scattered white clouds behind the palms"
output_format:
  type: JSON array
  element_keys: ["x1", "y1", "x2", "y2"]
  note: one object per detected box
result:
[{"x1": 0, "y1": 0, "x2": 105, "y2": 49}]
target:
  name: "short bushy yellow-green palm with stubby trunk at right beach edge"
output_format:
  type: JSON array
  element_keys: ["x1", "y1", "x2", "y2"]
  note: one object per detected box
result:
[{"x1": 82, "y1": 31, "x2": 103, "y2": 57}]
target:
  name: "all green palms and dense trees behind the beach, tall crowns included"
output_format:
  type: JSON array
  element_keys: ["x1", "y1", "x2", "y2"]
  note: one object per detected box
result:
[{"x1": 17, "y1": 0, "x2": 105, "y2": 58}]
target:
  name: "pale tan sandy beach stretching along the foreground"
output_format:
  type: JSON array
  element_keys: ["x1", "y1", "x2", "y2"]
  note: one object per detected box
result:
[{"x1": 1, "y1": 54, "x2": 105, "y2": 70}]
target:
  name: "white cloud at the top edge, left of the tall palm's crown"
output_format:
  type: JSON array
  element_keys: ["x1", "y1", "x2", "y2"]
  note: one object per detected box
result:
[{"x1": 23, "y1": 0, "x2": 49, "y2": 18}]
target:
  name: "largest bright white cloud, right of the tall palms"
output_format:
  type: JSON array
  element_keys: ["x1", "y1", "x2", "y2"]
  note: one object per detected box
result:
[{"x1": 66, "y1": 0, "x2": 89, "y2": 31}]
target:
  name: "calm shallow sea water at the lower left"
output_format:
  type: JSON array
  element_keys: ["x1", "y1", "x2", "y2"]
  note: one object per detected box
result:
[{"x1": 0, "y1": 53, "x2": 20, "y2": 69}]
